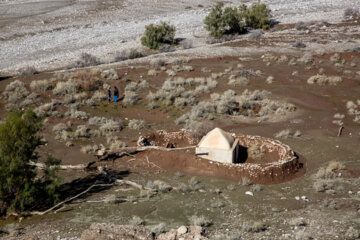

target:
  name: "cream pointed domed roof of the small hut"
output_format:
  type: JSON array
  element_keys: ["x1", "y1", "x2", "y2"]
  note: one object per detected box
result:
[{"x1": 199, "y1": 128, "x2": 235, "y2": 150}]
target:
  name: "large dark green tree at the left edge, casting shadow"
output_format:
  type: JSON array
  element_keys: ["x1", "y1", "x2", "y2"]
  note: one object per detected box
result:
[{"x1": 0, "y1": 110, "x2": 60, "y2": 214}]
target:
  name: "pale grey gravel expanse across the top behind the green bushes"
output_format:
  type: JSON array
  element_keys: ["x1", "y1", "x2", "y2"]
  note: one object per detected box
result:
[{"x1": 0, "y1": 0, "x2": 357, "y2": 74}]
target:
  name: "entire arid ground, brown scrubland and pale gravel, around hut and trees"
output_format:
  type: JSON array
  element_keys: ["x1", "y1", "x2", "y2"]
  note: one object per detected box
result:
[{"x1": 0, "y1": 0, "x2": 360, "y2": 240}]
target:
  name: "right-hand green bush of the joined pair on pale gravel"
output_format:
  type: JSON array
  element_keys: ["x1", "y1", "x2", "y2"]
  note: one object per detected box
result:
[{"x1": 239, "y1": 1, "x2": 270, "y2": 29}]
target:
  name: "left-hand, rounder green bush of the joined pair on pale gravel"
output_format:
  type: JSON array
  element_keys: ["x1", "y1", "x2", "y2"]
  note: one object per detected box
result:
[{"x1": 204, "y1": 3, "x2": 245, "y2": 38}]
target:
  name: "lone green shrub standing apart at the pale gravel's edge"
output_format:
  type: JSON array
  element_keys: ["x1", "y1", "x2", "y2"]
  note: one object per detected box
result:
[{"x1": 141, "y1": 22, "x2": 176, "y2": 49}]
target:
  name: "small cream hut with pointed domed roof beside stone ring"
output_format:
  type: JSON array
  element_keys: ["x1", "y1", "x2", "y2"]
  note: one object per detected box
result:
[{"x1": 195, "y1": 128, "x2": 240, "y2": 163}]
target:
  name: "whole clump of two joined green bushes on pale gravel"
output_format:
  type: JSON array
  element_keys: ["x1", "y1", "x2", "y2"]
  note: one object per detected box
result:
[{"x1": 204, "y1": 2, "x2": 270, "y2": 38}]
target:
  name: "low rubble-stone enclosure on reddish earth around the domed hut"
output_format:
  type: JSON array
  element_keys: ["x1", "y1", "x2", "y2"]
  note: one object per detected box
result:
[{"x1": 134, "y1": 130, "x2": 305, "y2": 184}]
